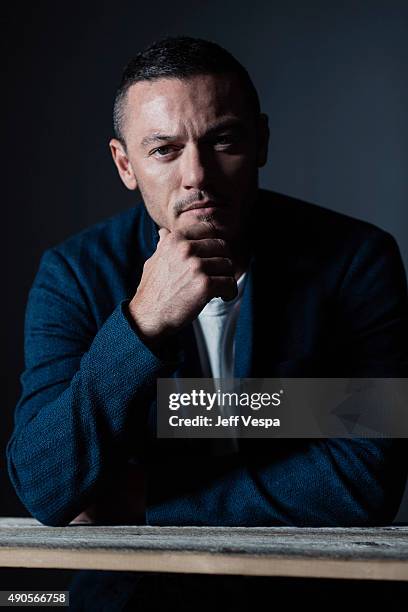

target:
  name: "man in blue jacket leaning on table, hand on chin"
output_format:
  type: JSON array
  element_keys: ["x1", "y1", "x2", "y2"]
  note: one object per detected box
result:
[{"x1": 7, "y1": 37, "x2": 408, "y2": 608}]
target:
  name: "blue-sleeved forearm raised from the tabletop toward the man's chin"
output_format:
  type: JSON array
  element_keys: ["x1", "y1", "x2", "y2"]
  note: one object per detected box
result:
[{"x1": 7, "y1": 304, "x2": 181, "y2": 525}]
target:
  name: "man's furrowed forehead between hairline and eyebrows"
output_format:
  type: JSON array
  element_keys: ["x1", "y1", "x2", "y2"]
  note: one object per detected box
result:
[{"x1": 125, "y1": 75, "x2": 250, "y2": 140}]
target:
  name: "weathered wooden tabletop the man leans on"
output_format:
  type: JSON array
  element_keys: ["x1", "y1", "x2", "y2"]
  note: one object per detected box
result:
[{"x1": 0, "y1": 518, "x2": 408, "y2": 580}]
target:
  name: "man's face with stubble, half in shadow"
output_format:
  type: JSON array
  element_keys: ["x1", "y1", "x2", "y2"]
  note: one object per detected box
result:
[{"x1": 110, "y1": 75, "x2": 268, "y2": 240}]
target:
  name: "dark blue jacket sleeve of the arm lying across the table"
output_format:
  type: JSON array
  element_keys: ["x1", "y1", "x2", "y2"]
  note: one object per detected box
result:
[{"x1": 147, "y1": 229, "x2": 408, "y2": 527}]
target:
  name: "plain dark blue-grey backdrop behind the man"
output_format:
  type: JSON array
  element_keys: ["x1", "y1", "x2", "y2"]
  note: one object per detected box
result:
[{"x1": 0, "y1": 0, "x2": 408, "y2": 589}]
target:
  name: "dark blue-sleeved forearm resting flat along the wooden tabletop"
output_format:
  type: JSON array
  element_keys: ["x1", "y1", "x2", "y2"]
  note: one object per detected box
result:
[{"x1": 147, "y1": 439, "x2": 407, "y2": 527}]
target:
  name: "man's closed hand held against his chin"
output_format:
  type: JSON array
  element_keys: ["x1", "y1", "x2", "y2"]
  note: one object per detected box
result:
[{"x1": 129, "y1": 223, "x2": 237, "y2": 342}]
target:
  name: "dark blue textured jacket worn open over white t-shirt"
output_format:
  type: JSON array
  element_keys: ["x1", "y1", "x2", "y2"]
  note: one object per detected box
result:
[{"x1": 7, "y1": 190, "x2": 408, "y2": 526}]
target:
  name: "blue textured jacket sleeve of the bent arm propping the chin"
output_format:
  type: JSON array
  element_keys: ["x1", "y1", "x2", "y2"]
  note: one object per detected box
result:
[{"x1": 6, "y1": 249, "x2": 182, "y2": 525}]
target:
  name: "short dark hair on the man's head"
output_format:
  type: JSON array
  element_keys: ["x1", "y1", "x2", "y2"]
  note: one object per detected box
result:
[{"x1": 113, "y1": 36, "x2": 261, "y2": 147}]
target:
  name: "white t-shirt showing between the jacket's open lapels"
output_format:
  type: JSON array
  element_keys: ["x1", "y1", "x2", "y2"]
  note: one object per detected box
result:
[{"x1": 193, "y1": 272, "x2": 246, "y2": 455}]
